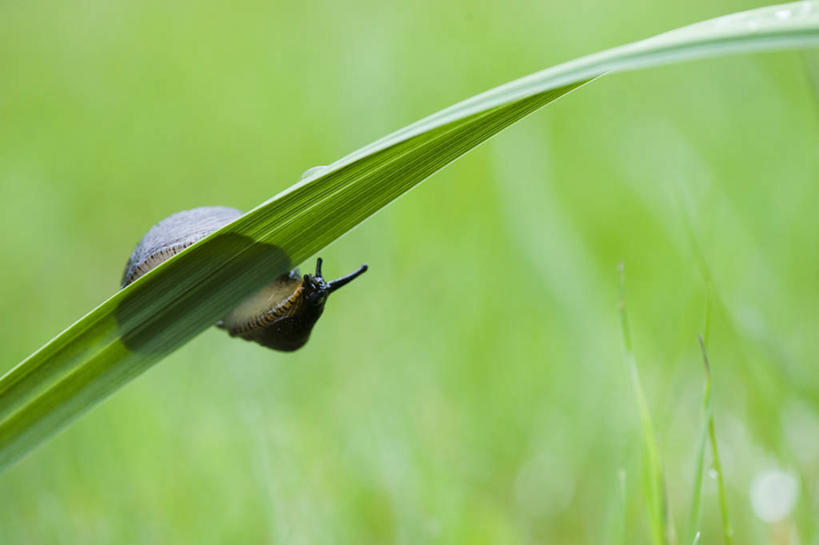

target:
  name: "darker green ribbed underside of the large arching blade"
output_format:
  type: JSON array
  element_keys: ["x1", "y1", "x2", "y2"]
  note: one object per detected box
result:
[{"x1": 0, "y1": 83, "x2": 582, "y2": 466}]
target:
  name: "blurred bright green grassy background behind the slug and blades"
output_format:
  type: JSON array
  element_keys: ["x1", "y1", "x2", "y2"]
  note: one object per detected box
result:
[{"x1": 0, "y1": 0, "x2": 819, "y2": 545}]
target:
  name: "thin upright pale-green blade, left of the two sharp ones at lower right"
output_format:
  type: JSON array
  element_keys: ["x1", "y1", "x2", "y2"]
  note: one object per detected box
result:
[{"x1": 617, "y1": 263, "x2": 673, "y2": 545}]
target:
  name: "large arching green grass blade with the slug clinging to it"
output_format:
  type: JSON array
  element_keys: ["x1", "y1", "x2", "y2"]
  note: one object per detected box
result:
[{"x1": 0, "y1": 1, "x2": 819, "y2": 468}]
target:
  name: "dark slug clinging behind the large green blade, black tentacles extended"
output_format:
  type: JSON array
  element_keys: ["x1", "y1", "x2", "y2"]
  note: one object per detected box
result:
[{"x1": 122, "y1": 206, "x2": 367, "y2": 352}]
